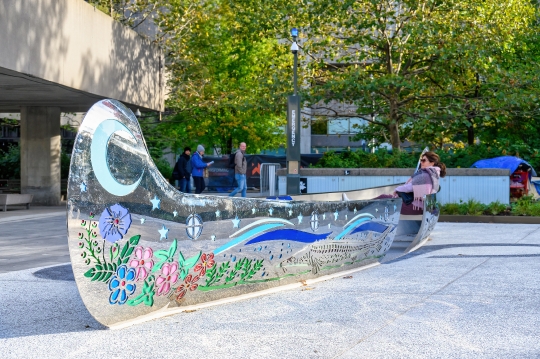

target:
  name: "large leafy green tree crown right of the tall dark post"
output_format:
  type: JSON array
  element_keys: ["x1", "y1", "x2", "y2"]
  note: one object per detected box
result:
[{"x1": 304, "y1": 0, "x2": 534, "y2": 151}]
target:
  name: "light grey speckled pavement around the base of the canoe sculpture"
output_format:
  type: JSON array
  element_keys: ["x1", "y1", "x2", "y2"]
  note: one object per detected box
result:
[{"x1": 0, "y1": 205, "x2": 540, "y2": 359}]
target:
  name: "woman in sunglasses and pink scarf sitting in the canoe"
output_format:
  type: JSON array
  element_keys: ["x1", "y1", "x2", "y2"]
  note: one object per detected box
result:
[{"x1": 393, "y1": 152, "x2": 446, "y2": 210}]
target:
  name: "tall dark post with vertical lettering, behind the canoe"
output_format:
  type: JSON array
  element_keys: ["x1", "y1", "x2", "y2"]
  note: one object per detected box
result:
[{"x1": 287, "y1": 28, "x2": 300, "y2": 195}]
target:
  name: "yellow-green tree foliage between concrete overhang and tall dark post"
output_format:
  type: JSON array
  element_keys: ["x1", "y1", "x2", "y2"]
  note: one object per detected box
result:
[{"x1": 150, "y1": 0, "x2": 298, "y2": 153}]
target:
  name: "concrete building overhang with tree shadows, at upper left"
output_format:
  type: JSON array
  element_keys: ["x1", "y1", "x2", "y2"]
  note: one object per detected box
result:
[{"x1": 0, "y1": 0, "x2": 165, "y2": 112}]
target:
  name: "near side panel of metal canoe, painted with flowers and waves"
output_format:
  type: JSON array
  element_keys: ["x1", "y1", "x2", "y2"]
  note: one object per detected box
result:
[{"x1": 67, "y1": 100, "x2": 401, "y2": 326}]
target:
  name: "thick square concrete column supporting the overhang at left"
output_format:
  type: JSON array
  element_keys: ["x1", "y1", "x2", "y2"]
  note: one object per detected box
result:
[{"x1": 20, "y1": 107, "x2": 61, "y2": 206}]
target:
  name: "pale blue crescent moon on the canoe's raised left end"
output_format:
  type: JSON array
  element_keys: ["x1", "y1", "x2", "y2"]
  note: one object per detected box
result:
[{"x1": 90, "y1": 120, "x2": 144, "y2": 197}]
